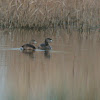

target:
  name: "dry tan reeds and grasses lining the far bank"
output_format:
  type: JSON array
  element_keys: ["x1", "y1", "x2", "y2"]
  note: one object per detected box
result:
[{"x1": 0, "y1": 0, "x2": 100, "y2": 31}]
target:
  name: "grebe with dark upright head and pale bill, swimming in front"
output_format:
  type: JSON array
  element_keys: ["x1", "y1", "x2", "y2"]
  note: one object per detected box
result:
[{"x1": 38, "y1": 38, "x2": 52, "y2": 50}]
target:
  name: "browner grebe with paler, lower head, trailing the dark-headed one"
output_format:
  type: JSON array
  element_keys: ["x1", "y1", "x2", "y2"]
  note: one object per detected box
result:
[{"x1": 21, "y1": 40, "x2": 37, "y2": 50}]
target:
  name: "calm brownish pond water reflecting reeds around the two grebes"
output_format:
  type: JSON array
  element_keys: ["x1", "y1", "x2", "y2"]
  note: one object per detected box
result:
[{"x1": 0, "y1": 29, "x2": 100, "y2": 100}]
